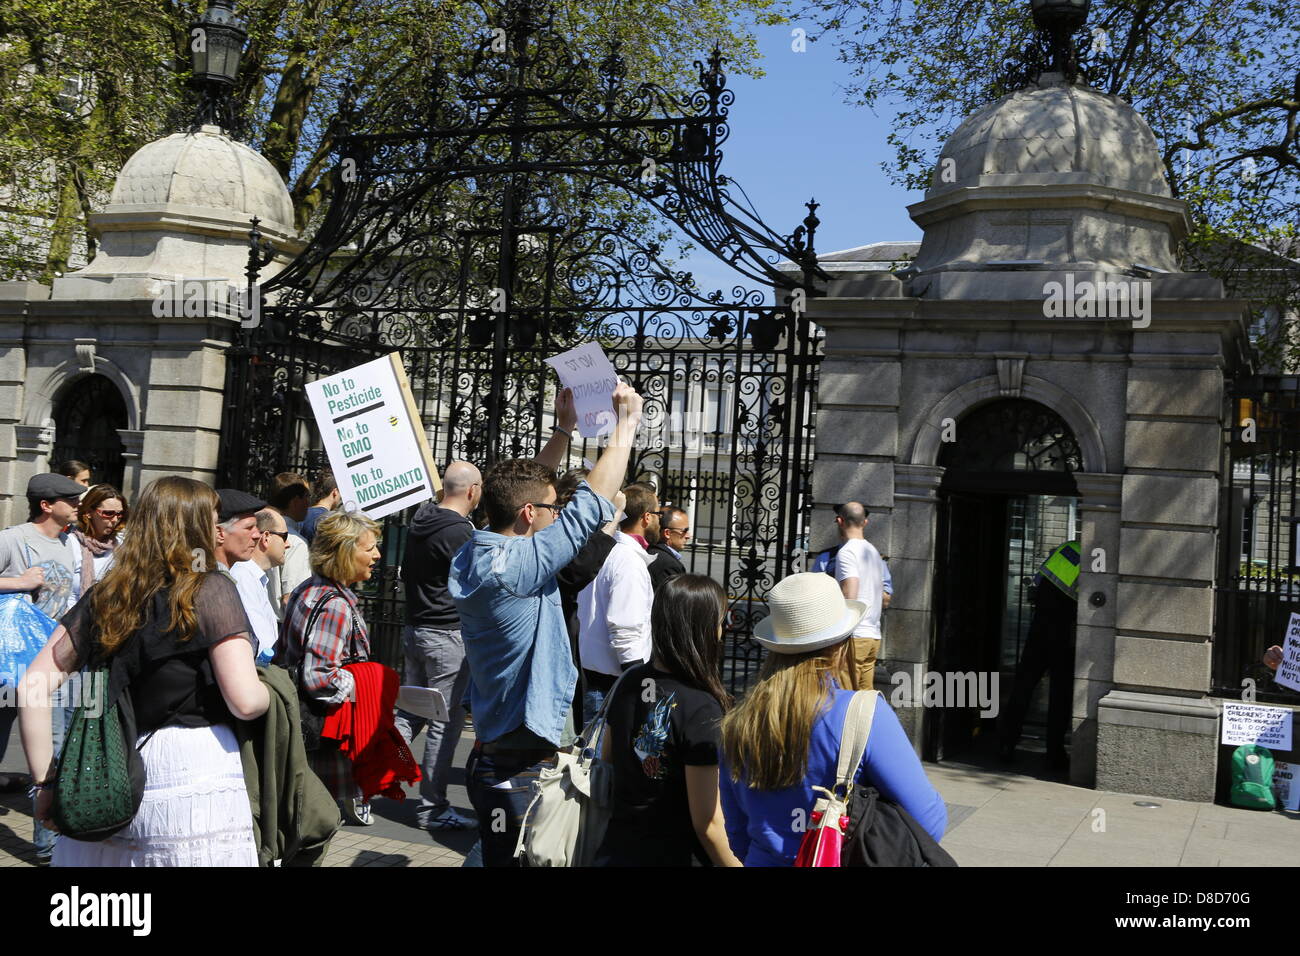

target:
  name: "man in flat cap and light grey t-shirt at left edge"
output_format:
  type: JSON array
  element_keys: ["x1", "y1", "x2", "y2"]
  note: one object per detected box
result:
[{"x1": 0, "y1": 473, "x2": 86, "y2": 864}]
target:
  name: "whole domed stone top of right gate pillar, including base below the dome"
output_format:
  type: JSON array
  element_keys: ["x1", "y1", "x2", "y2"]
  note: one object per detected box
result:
[{"x1": 907, "y1": 73, "x2": 1190, "y2": 282}]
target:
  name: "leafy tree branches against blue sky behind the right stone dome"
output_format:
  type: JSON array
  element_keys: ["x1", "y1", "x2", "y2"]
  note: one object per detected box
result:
[{"x1": 797, "y1": 0, "x2": 1300, "y2": 351}]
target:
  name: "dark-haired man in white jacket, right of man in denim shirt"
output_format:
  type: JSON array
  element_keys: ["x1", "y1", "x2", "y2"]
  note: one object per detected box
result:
[{"x1": 577, "y1": 485, "x2": 659, "y2": 723}]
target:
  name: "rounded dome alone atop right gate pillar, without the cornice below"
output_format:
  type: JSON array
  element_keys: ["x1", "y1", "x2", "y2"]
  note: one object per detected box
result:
[{"x1": 926, "y1": 74, "x2": 1171, "y2": 196}]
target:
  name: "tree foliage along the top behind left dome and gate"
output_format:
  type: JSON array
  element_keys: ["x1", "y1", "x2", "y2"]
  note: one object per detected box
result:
[{"x1": 0, "y1": 0, "x2": 780, "y2": 281}]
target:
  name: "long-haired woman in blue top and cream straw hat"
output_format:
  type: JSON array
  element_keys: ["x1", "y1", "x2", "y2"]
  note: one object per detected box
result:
[{"x1": 719, "y1": 574, "x2": 948, "y2": 866}]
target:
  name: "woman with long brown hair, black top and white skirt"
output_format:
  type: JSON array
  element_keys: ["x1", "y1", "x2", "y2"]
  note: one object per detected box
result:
[{"x1": 18, "y1": 477, "x2": 269, "y2": 866}]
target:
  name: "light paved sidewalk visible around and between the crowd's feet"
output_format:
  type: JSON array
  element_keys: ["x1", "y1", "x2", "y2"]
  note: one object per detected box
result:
[{"x1": 0, "y1": 727, "x2": 1300, "y2": 868}]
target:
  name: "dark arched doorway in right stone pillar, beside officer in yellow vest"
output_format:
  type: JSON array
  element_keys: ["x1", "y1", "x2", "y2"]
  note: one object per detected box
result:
[{"x1": 924, "y1": 399, "x2": 1083, "y2": 771}]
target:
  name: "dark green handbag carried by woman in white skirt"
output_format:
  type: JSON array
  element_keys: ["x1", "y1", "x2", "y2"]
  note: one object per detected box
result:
[{"x1": 51, "y1": 667, "x2": 194, "y2": 843}]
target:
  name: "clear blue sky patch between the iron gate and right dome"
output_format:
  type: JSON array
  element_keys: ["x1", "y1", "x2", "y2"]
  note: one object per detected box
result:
[{"x1": 683, "y1": 25, "x2": 922, "y2": 299}]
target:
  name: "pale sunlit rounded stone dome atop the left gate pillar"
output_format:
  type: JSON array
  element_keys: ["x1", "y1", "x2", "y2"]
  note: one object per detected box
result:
[{"x1": 104, "y1": 126, "x2": 294, "y2": 234}]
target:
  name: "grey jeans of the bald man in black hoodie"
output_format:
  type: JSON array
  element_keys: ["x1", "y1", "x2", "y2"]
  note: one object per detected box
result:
[{"x1": 394, "y1": 627, "x2": 469, "y2": 826}]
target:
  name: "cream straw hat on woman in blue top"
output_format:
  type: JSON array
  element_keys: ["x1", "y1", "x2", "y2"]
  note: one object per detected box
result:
[{"x1": 754, "y1": 572, "x2": 867, "y2": 654}]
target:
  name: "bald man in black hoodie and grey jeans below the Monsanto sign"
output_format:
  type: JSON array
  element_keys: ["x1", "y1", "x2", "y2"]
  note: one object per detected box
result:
[{"x1": 395, "y1": 462, "x2": 484, "y2": 831}]
